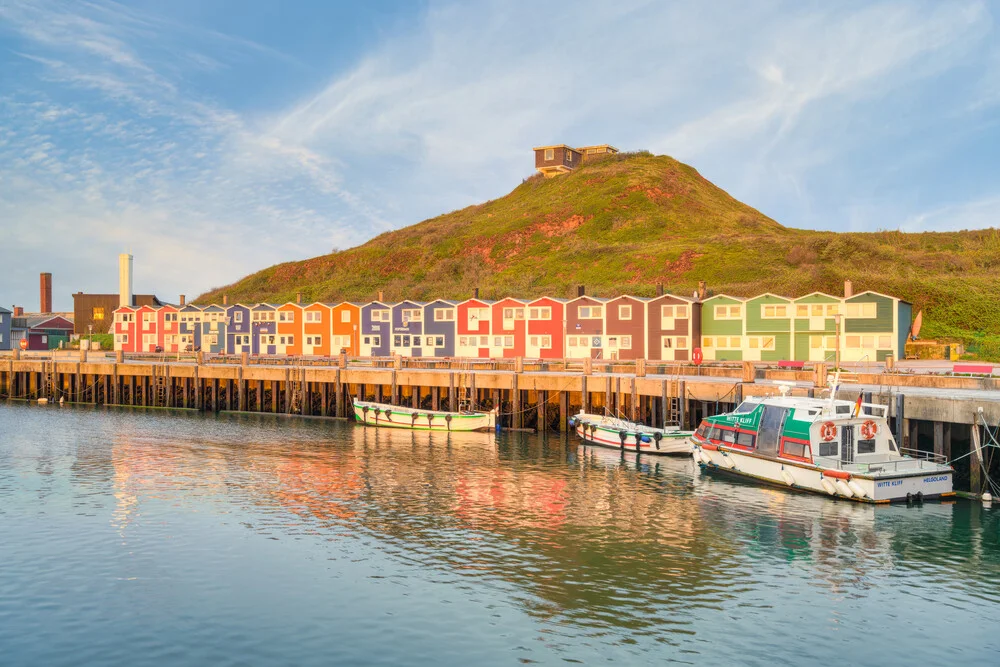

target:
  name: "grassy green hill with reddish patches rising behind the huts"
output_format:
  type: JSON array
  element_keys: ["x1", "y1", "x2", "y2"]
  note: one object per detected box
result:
[{"x1": 198, "y1": 153, "x2": 1000, "y2": 358}]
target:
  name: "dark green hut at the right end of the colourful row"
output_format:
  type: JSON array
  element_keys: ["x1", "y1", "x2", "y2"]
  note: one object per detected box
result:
[{"x1": 840, "y1": 291, "x2": 913, "y2": 362}]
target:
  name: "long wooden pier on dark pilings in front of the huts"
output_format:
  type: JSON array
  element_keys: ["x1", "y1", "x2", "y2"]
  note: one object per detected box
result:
[{"x1": 0, "y1": 351, "x2": 1000, "y2": 493}]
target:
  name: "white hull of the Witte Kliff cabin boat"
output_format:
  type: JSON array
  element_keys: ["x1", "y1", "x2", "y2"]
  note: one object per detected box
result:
[{"x1": 692, "y1": 443, "x2": 954, "y2": 503}]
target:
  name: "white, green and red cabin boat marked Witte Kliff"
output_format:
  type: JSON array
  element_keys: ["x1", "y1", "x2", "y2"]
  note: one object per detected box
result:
[{"x1": 691, "y1": 385, "x2": 954, "y2": 503}]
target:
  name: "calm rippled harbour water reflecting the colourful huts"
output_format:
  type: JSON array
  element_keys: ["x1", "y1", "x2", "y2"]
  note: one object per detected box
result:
[{"x1": 0, "y1": 404, "x2": 1000, "y2": 665}]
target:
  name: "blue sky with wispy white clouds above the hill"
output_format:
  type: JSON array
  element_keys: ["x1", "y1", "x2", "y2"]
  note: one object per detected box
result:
[{"x1": 0, "y1": 0, "x2": 1000, "y2": 311}]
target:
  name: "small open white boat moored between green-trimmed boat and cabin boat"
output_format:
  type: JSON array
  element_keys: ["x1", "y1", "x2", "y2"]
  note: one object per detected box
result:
[{"x1": 570, "y1": 410, "x2": 693, "y2": 456}]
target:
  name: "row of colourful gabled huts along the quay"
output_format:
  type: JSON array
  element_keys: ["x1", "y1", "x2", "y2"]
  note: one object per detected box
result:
[{"x1": 113, "y1": 290, "x2": 912, "y2": 361}]
